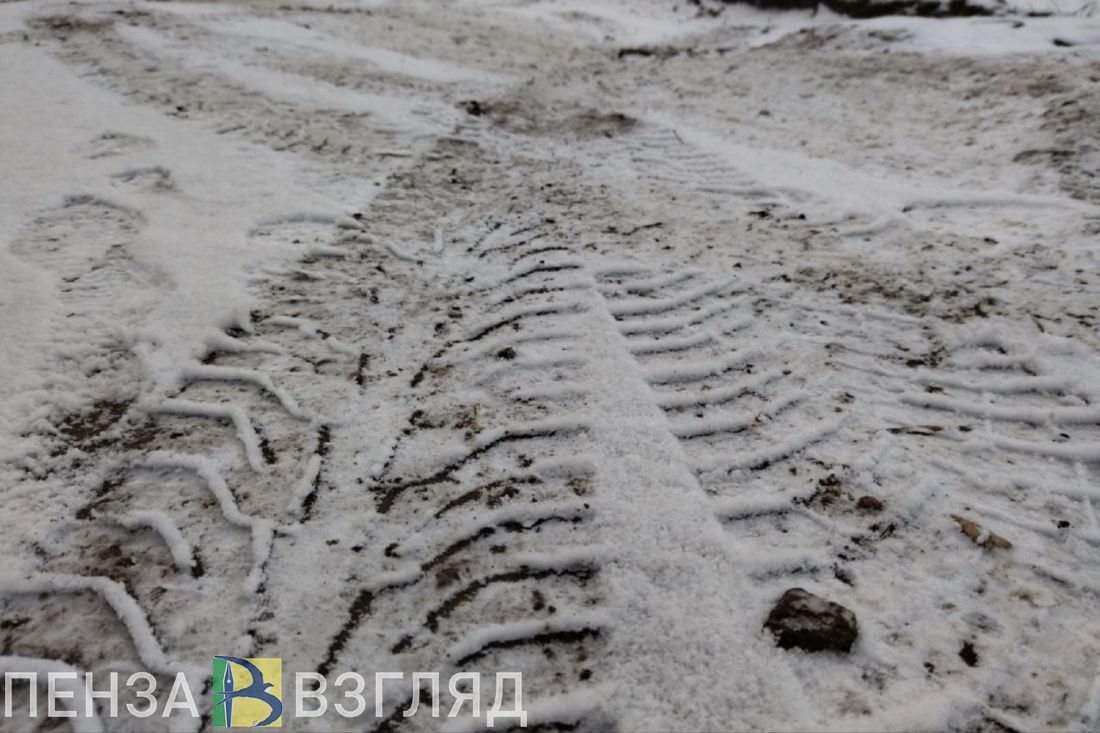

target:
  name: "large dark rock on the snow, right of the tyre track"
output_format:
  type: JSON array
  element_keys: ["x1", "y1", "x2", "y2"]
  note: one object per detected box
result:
[{"x1": 763, "y1": 588, "x2": 859, "y2": 652}]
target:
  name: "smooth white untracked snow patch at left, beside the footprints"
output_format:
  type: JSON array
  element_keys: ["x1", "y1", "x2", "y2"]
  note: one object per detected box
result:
[{"x1": 0, "y1": 39, "x2": 343, "y2": 413}]
